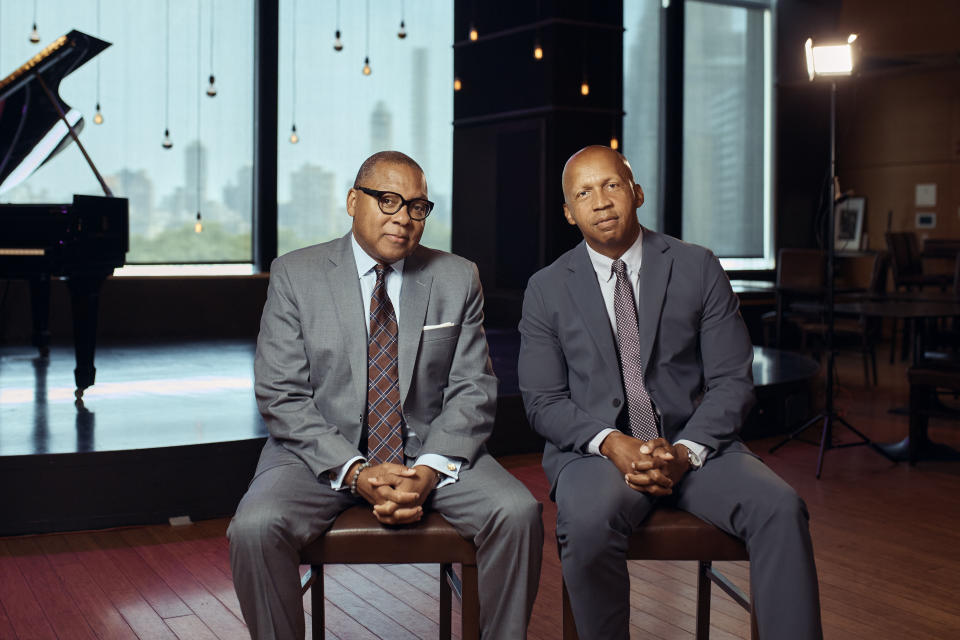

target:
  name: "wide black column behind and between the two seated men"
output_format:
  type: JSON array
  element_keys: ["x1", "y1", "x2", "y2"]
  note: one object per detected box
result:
[{"x1": 451, "y1": 0, "x2": 623, "y2": 326}]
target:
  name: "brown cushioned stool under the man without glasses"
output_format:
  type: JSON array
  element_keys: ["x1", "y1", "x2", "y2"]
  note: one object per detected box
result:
[{"x1": 562, "y1": 507, "x2": 758, "y2": 640}]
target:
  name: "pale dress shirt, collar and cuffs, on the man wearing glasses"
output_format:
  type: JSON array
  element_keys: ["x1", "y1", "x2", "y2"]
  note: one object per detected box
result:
[{"x1": 330, "y1": 234, "x2": 463, "y2": 490}]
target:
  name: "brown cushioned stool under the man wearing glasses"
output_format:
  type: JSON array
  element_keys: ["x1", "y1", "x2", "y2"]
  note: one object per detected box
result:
[{"x1": 300, "y1": 506, "x2": 480, "y2": 640}]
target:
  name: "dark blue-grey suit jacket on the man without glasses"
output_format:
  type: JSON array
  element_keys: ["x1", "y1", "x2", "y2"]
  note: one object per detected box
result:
[{"x1": 519, "y1": 229, "x2": 753, "y2": 496}]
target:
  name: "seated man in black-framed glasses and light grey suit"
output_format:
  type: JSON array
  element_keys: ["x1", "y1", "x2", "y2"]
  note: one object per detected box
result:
[{"x1": 227, "y1": 151, "x2": 543, "y2": 638}]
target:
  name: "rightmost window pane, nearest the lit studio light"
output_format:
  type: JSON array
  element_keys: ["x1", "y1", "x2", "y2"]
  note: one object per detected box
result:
[{"x1": 683, "y1": 1, "x2": 773, "y2": 268}]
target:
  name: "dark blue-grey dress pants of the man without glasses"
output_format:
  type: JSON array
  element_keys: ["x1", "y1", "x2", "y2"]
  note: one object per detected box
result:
[{"x1": 556, "y1": 452, "x2": 823, "y2": 640}]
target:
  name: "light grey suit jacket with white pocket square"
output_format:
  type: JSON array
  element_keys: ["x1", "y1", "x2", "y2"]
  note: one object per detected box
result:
[{"x1": 254, "y1": 234, "x2": 497, "y2": 477}]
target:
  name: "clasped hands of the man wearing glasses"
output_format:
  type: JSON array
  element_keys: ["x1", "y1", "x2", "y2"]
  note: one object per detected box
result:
[{"x1": 347, "y1": 462, "x2": 438, "y2": 524}]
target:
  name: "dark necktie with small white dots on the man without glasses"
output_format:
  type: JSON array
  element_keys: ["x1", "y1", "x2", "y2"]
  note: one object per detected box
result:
[{"x1": 612, "y1": 260, "x2": 659, "y2": 440}]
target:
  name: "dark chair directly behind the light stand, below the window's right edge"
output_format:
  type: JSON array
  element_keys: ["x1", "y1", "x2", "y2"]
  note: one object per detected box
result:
[{"x1": 762, "y1": 249, "x2": 826, "y2": 348}]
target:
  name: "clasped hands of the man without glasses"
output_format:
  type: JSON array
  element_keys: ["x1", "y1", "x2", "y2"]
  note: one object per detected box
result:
[{"x1": 600, "y1": 433, "x2": 690, "y2": 496}]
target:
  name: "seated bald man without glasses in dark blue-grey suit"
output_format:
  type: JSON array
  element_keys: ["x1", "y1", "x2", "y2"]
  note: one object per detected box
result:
[{"x1": 519, "y1": 147, "x2": 822, "y2": 640}]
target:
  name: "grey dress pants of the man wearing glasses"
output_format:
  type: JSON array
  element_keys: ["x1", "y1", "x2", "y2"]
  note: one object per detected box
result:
[{"x1": 227, "y1": 440, "x2": 543, "y2": 638}]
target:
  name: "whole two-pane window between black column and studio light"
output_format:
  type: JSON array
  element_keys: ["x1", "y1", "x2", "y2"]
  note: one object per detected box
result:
[{"x1": 623, "y1": 0, "x2": 773, "y2": 269}]
